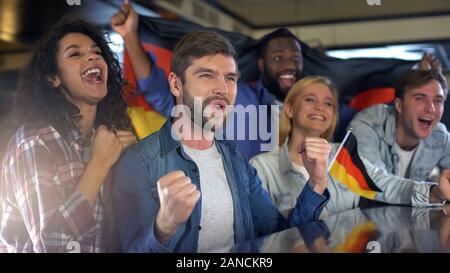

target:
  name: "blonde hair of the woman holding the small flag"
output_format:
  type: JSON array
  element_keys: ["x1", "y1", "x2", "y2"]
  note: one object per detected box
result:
[{"x1": 278, "y1": 76, "x2": 339, "y2": 146}]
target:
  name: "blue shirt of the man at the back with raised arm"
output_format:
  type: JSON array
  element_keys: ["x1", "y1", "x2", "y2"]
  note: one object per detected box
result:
[{"x1": 138, "y1": 53, "x2": 280, "y2": 160}]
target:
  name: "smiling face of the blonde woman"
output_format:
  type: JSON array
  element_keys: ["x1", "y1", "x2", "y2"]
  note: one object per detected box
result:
[{"x1": 285, "y1": 83, "x2": 336, "y2": 137}]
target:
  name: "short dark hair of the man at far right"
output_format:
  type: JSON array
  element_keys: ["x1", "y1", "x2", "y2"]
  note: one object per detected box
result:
[{"x1": 395, "y1": 69, "x2": 447, "y2": 99}]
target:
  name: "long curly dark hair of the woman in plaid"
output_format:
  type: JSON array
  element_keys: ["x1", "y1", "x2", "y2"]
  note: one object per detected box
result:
[{"x1": 15, "y1": 17, "x2": 131, "y2": 132}]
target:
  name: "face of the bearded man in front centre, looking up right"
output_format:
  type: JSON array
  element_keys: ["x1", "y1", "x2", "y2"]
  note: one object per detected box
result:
[{"x1": 169, "y1": 54, "x2": 238, "y2": 130}]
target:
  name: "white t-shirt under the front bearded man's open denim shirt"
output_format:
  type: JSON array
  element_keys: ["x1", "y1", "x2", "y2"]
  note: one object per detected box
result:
[{"x1": 183, "y1": 144, "x2": 234, "y2": 252}]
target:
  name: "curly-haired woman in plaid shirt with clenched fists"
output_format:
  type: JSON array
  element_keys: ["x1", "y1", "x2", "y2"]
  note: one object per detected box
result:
[{"x1": 0, "y1": 19, "x2": 136, "y2": 252}]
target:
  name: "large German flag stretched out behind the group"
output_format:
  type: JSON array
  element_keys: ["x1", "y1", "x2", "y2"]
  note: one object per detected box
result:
[{"x1": 119, "y1": 15, "x2": 415, "y2": 141}]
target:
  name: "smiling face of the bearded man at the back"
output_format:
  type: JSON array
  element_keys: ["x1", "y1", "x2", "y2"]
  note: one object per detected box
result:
[{"x1": 259, "y1": 37, "x2": 303, "y2": 100}]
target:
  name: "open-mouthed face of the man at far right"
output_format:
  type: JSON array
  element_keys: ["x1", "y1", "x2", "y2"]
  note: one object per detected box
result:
[{"x1": 395, "y1": 80, "x2": 444, "y2": 142}]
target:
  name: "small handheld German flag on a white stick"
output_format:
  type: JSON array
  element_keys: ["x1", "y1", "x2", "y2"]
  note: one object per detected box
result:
[{"x1": 329, "y1": 130, "x2": 381, "y2": 200}]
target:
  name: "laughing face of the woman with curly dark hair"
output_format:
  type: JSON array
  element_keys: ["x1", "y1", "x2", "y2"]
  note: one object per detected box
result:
[{"x1": 51, "y1": 33, "x2": 108, "y2": 110}]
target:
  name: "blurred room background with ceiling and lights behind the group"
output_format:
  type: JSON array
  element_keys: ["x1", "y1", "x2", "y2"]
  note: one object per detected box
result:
[{"x1": 0, "y1": 0, "x2": 450, "y2": 157}]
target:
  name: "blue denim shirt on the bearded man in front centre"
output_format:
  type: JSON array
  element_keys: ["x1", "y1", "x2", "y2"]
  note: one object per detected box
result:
[{"x1": 107, "y1": 121, "x2": 329, "y2": 252}]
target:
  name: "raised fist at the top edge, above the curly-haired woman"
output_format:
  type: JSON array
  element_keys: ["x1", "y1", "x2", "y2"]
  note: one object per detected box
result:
[{"x1": 110, "y1": 0, "x2": 139, "y2": 40}]
